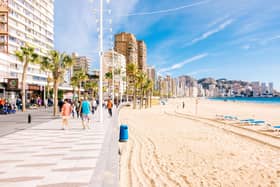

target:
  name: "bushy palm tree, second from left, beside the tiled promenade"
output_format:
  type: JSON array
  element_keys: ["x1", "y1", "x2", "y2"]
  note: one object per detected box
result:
[{"x1": 40, "y1": 50, "x2": 74, "y2": 116}]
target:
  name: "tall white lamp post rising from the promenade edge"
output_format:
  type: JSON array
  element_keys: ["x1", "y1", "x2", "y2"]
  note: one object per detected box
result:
[{"x1": 99, "y1": 0, "x2": 103, "y2": 123}]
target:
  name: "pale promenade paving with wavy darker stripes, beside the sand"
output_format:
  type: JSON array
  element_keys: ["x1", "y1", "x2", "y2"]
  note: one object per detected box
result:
[{"x1": 0, "y1": 110, "x2": 118, "y2": 187}]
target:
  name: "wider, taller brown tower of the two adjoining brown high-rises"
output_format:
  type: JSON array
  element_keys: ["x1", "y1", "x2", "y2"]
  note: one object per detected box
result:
[{"x1": 114, "y1": 32, "x2": 138, "y2": 65}]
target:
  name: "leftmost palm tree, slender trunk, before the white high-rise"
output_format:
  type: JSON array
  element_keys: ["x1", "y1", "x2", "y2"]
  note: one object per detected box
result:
[{"x1": 15, "y1": 43, "x2": 40, "y2": 112}]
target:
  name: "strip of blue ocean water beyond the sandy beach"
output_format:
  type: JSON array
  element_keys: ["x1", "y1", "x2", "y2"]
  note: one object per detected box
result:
[{"x1": 209, "y1": 97, "x2": 280, "y2": 105}]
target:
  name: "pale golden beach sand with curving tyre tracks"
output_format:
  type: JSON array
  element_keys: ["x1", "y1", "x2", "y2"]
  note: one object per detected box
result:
[{"x1": 119, "y1": 99, "x2": 280, "y2": 187}]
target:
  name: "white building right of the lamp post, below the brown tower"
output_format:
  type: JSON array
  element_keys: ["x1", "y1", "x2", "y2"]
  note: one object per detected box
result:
[{"x1": 103, "y1": 51, "x2": 126, "y2": 98}]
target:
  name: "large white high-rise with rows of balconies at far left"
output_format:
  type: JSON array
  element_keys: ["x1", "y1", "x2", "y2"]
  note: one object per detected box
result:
[{"x1": 0, "y1": 0, "x2": 54, "y2": 99}]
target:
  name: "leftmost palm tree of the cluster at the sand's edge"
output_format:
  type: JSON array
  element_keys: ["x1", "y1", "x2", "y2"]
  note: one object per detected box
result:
[{"x1": 126, "y1": 63, "x2": 138, "y2": 109}]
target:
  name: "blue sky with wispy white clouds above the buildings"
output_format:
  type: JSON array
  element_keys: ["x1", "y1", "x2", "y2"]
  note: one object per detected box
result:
[{"x1": 55, "y1": 0, "x2": 280, "y2": 91}]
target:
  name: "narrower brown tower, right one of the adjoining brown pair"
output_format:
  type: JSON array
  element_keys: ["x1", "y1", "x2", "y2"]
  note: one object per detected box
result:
[{"x1": 137, "y1": 40, "x2": 147, "y2": 72}]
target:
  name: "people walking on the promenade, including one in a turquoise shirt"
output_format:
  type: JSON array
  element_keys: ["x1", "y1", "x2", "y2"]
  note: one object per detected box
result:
[{"x1": 61, "y1": 97, "x2": 113, "y2": 130}]
